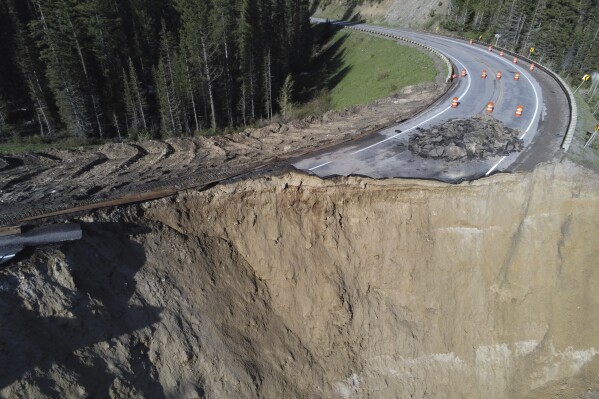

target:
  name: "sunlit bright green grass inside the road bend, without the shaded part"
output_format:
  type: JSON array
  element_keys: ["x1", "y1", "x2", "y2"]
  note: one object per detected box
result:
[{"x1": 328, "y1": 30, "x2": 438, "y2": 109}]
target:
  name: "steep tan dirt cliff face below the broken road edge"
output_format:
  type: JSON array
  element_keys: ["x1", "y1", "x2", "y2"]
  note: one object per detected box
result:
[{"x1": 0, "y1": 163, "x2": 599, "y2": 399}]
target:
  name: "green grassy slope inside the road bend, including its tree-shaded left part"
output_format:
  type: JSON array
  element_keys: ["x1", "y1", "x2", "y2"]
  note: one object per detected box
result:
[{"x1": 295, "y1": 26, "x2": 438, "y2": 117}]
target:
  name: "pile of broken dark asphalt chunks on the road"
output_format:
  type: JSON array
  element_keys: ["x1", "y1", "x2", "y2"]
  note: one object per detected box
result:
[{"x1": 408, "y1": 115, "x2": 524, "y2": 161}]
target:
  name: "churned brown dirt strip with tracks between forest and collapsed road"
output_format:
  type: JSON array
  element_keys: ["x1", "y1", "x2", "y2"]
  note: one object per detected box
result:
[{"x1": 0, "y1": 83, "x2": 446, "y2": 225}]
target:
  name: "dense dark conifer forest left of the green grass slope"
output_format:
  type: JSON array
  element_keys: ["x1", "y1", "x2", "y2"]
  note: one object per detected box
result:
[{"x1": 0, "y1": 0, "x2": 311, "y2": 138}]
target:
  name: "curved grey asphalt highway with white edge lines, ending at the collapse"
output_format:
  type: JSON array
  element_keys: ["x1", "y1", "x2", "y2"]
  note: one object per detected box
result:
[{"x1": 293, "y1": 21, "x2": 570, "y2": 182}]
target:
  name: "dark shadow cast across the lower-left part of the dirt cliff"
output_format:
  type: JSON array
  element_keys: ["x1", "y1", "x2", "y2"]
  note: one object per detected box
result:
[{"x1": 0, "y1": 223, "x2": 165, "y2": 398}]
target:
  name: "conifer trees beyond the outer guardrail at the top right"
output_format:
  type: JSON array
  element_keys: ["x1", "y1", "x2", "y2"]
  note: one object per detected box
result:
[{"x1": 445, "y1": 0, "x2": 599, "y2": 77}]
